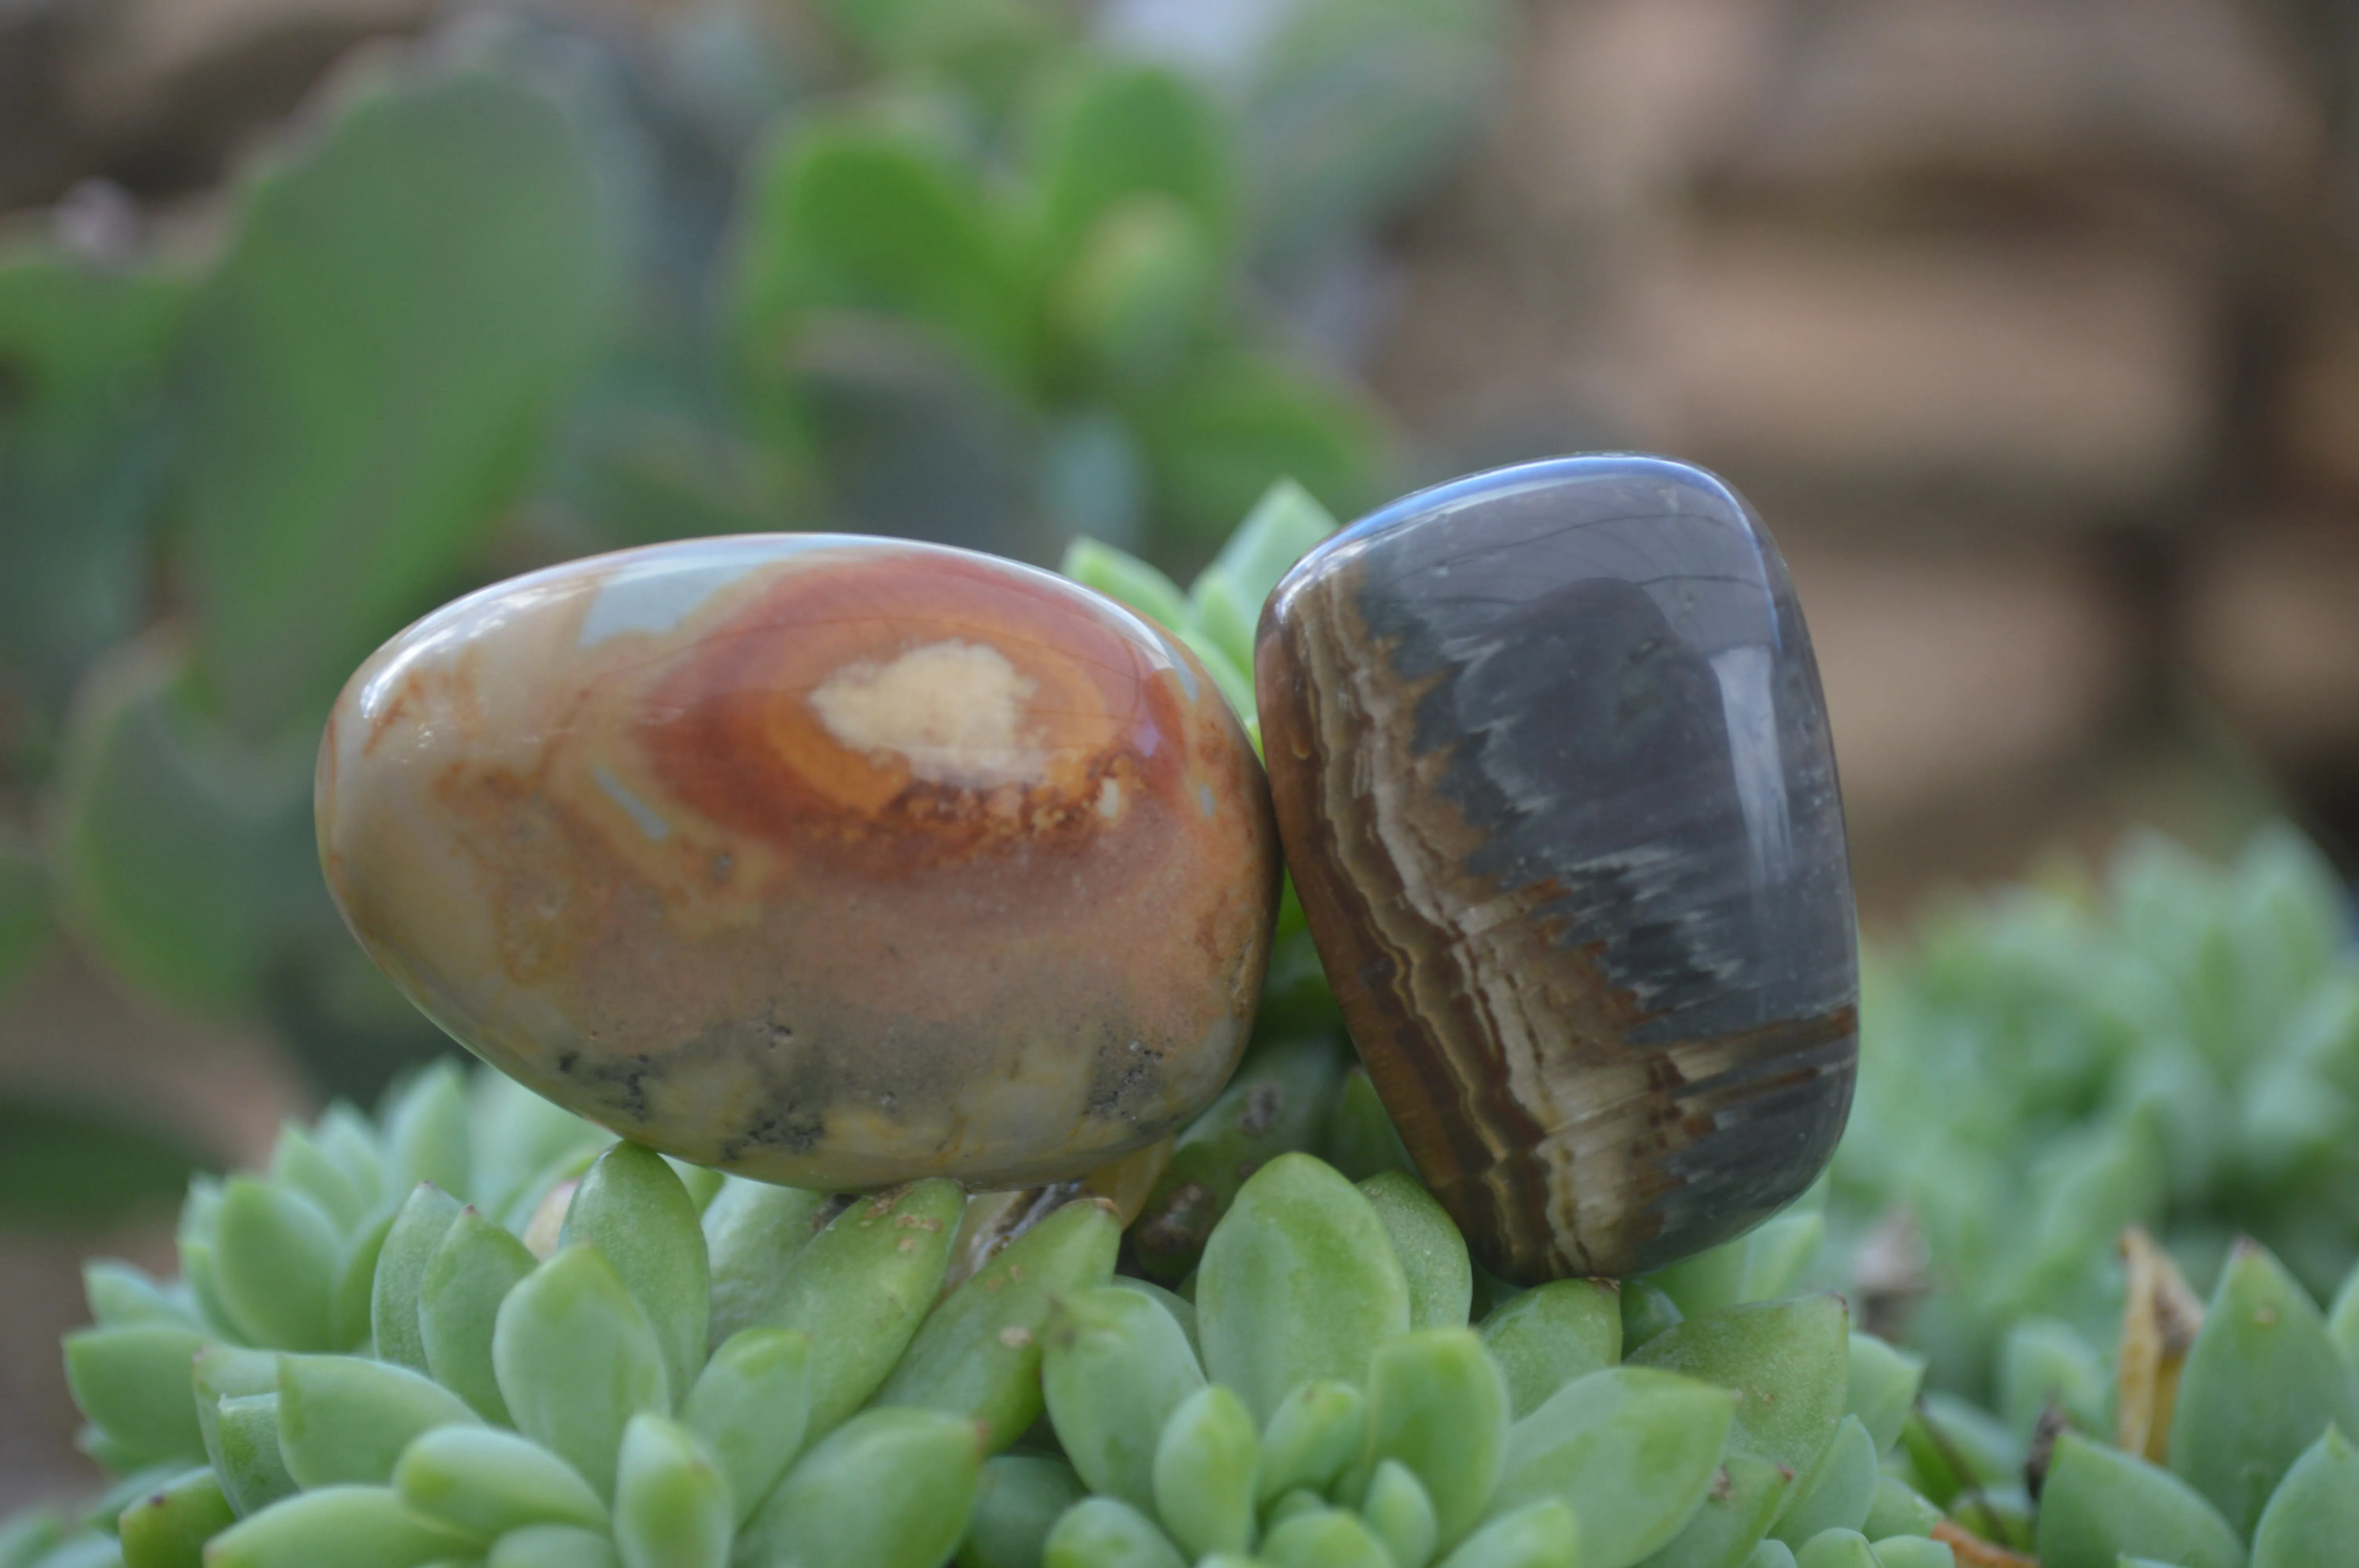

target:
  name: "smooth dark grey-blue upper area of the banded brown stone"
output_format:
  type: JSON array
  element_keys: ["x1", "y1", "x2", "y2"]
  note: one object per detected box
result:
[{"x1": 1338, "y1": 457, "x2": 1857, "y2": 1040}]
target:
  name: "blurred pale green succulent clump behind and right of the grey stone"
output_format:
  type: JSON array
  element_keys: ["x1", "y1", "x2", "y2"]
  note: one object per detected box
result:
[{"x1": 1828, "y1": 828, "x2": 2359, "y2": 1398}]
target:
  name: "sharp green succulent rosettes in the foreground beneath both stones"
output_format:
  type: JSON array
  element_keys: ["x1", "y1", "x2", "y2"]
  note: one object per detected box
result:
[{"x1": 0, "y1": 1068, "x2": 2000, "y2": 1568}]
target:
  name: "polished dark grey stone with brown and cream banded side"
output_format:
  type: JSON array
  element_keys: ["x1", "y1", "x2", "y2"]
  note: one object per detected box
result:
[{"x1": 1255, "y1": 457, "x2": 1859, "y2": 1283}]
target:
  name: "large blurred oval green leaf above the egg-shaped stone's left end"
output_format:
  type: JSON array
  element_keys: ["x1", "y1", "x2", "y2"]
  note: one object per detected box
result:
[{"x1": 177, "y1": 66, "x2": 620, "y2": 738}]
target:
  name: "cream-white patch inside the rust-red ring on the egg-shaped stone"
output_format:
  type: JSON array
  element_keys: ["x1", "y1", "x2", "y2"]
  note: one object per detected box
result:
[{"x1": 809, "y1": 639, "x2": 1047, "y2": 790}]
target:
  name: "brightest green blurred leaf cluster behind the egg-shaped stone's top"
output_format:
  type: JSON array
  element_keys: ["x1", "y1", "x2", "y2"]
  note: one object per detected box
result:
[{"x1": 734, "y1": 56, "x2": 1387, "y2": 561}]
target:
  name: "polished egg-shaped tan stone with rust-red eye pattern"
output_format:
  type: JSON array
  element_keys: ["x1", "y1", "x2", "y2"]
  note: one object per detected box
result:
[{"x1": 318, "y1": 535, "x2": 1276, "y2": 1189}]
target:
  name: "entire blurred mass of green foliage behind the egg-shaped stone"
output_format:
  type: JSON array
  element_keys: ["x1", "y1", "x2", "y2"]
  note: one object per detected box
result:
[{"x1": 0, "y1": 0, "x2": 1503, "y2": 1217}]
